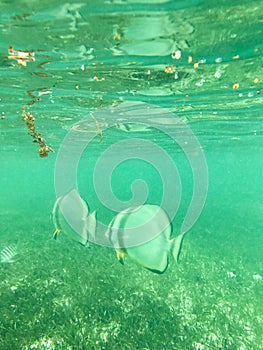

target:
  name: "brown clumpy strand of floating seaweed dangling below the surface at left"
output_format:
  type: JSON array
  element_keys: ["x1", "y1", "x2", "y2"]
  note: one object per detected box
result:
[{"x1": 22, "y1": 106, "x2": 54, "y2": 158}]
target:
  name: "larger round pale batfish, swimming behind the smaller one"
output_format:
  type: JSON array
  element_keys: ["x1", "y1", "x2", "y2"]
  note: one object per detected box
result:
[{"x1": 106, "y1": 204, "x2": 183, "y2": 273}]
